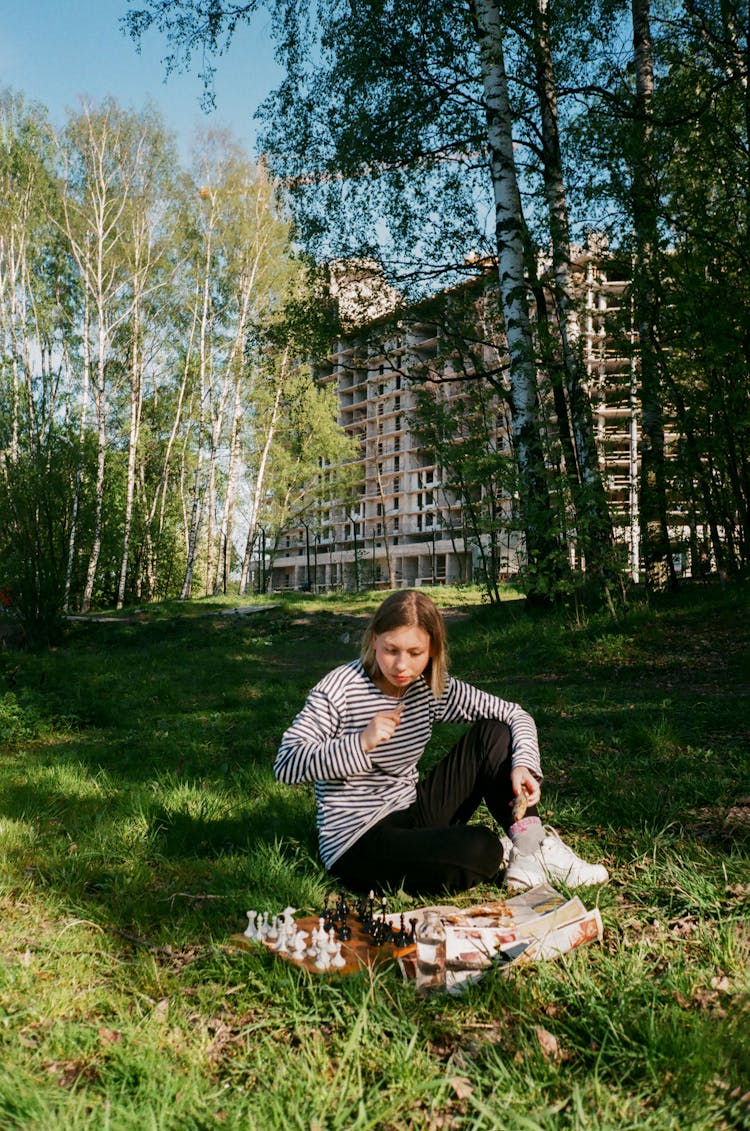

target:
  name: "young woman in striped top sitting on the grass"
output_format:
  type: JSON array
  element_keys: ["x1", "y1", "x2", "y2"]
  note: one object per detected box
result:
[{"x1": 274, "y1": 589, "x2": 607, "y2": 892}]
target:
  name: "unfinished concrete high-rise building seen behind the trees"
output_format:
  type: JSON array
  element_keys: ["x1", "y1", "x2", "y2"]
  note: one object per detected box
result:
[{"x1": 268, "y1": 256, "x2": 638, "y2": 592}]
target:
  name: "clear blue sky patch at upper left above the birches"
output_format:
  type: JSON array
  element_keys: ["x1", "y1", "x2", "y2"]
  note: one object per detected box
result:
[{"x1": 0, "y1": 0, "x2": 279, "y2": 156}]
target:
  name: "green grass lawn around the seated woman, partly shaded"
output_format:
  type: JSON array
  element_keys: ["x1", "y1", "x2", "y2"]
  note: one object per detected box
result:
[{"x1": 0, "y1": 588, "x2": 750, "y2": 1131}]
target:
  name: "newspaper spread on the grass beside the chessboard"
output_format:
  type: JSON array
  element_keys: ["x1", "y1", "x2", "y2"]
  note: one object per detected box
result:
[{"x1": 398, "y1": 883, "x2": 603, "y2": 993}]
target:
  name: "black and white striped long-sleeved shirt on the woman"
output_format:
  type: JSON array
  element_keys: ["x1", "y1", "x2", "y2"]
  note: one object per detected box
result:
[{"x1": 274, "y1": 659, "x2": 542, "y2": 867}]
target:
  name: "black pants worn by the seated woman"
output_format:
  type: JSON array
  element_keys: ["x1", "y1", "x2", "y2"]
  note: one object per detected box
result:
[{"x1": 330, "y1": 719, "x2": 536, "y2": 892}]
